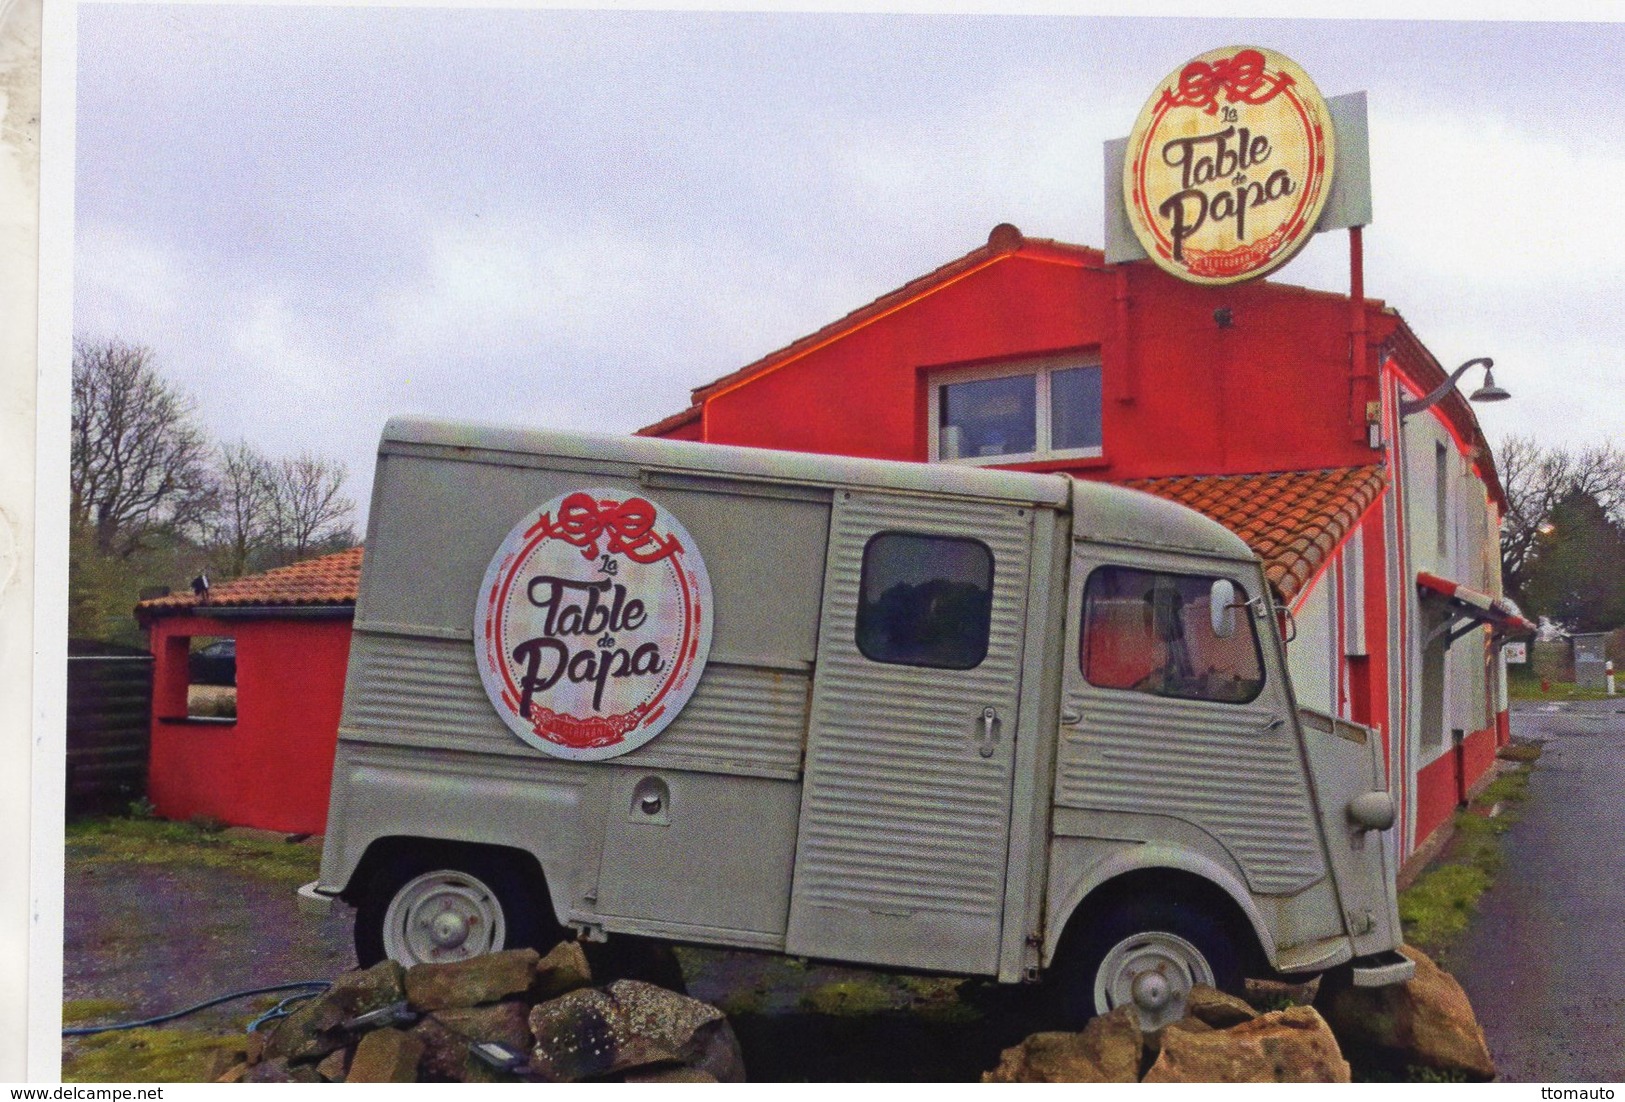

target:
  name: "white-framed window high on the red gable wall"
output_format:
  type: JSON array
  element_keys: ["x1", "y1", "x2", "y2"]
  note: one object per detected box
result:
[{"x1": 931, "y1": 356, "x2": 1102, "y2": 463}]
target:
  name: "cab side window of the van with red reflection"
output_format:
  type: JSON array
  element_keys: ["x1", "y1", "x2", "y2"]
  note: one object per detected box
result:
[{"x1": 1077, "y1": 566, "x2": 1264, "y2": 704}]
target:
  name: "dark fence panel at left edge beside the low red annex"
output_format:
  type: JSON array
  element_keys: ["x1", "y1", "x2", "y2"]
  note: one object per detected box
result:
[{"x1": 67, "y1": 640, "x2": 153, "y2": 816}]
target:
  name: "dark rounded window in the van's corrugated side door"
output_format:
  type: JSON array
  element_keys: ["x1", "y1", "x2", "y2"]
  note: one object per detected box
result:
[{"x1": 856, "y1": 531, "x2": 993, "y2": 670}]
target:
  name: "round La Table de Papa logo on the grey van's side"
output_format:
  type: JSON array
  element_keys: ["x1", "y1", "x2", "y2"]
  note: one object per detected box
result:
[{"x1": 475, "y1": 489, "x2": 712, "y2": 761}]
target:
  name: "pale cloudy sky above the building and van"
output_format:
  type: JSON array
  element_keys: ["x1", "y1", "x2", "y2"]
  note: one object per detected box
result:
[{"x1": 75, "y1": 5, "x2": 1625, "y2": 529}]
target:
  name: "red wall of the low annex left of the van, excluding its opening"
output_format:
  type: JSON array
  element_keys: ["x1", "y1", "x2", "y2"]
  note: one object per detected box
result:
[{"x1": 148, "y1": 616, "x2": 349, "y2": 834}]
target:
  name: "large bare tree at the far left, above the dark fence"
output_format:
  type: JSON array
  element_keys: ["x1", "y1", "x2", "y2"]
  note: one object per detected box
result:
[{"x1": 68, "y1": 340, "x2": 210, "y2": 559}]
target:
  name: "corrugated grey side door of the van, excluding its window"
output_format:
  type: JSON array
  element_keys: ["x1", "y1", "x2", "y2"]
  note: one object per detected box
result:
[{"x1": 790, "y1": 492, "x2": 1032, "y2": 970}]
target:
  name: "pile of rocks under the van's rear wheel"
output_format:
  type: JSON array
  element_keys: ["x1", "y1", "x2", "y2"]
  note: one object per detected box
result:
[{"x1": 218, "y1": 943, "x2": 744, "y2": 1082}]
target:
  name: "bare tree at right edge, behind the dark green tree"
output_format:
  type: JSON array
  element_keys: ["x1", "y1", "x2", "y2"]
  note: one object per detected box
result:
[{"x1": 1495, "y1": 436, "x2": 1625, "y2": 601}]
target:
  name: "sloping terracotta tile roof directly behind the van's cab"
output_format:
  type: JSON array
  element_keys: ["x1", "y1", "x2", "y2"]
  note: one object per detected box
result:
[{"x1": 1126, "y1": 466, "x2": 1385, "y2": 601}]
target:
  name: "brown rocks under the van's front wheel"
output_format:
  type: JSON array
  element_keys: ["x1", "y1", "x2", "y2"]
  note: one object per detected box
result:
[{"x1": 982, "y1": 946, "x2": 1495, "y2": 1082}]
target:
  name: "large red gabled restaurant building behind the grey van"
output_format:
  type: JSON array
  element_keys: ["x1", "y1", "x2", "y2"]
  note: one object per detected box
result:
[{"x1": 642, "y1": 224, "x2": 1523, "y2": 857}]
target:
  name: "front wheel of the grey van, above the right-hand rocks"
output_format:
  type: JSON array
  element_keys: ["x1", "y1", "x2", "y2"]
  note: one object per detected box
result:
[{"x1": 1063, "y1": 902, "x2": 1246, "y2": 1029}]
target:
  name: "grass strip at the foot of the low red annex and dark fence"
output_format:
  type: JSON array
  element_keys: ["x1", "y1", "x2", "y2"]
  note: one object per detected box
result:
[{"x1": 65, "y1": 818, "x2": 322, "y2": 887}]
